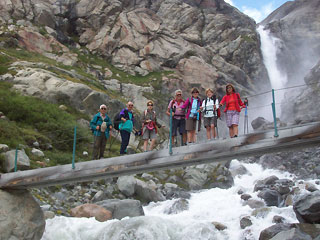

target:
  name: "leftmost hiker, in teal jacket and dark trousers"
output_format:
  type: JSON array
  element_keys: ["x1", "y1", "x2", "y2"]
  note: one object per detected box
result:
[{"x1": 90, "y1": 104, "x2": 112, "y2": 159}]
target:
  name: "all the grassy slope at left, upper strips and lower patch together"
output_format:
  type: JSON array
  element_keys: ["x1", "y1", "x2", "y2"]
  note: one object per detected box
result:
[{"x1": 0, "y1": 33, "x2": 172, "y2": 170}]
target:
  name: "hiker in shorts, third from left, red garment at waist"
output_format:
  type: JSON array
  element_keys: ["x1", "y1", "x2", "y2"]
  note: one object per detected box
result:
[{"x1": 141, "y1": 100, "x2": 162, "y2": 152}]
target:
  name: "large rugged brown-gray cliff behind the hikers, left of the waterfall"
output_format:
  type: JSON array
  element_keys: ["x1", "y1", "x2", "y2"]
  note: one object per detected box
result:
[{"x1": 0, "y1": 0, "x2": 268, "y2": 101}]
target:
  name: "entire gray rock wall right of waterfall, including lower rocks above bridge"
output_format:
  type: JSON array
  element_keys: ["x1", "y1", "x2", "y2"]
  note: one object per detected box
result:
[{"x1": 261, "y1": 0, "x2": 320, "y2": 123}]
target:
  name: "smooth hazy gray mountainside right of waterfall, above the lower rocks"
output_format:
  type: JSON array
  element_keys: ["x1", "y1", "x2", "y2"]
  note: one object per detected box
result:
[{"x1": 261, "y1": 0, "x2": 320, "y2": 85}]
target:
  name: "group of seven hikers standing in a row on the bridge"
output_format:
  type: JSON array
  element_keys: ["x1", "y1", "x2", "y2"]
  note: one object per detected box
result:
[{"x1": 90, "y1": 84, "x2": 246, "y2": 159}]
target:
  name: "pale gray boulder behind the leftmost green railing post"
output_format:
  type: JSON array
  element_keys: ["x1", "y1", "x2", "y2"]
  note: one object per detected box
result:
[{"x1": 2, "y1": 150, "x2": 30, "y2": 172}]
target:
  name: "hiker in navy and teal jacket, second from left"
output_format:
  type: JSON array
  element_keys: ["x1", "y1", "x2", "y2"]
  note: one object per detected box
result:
[{"x1": 119, "y1": 102, "x2": 134, "y2": 154}]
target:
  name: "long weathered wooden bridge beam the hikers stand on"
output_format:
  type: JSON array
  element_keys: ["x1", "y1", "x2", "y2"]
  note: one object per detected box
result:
[{"x1": 0, "y1": 122, "x2": 320, "y2": 189}]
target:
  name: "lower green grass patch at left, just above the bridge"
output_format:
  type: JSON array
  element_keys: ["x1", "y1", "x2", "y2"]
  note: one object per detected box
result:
[{"x1": 0, "y1": 82, "x2": 120, "y2": 171}]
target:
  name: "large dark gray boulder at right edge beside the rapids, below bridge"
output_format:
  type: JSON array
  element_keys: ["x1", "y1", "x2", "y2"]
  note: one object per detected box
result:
[{"x1": 293, "y1": 191, "x2": 320, "y2": 223}]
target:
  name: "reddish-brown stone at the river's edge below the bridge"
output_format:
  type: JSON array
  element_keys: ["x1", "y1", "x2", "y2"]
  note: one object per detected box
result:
[{"x1": 70, "y1": 203, "x2": 112, "y2": 222}]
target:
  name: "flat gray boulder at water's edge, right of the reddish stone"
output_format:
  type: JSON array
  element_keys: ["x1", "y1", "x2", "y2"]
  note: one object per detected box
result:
[{"x1": 96, "y1": 199, "x2": 144, "y2": 219}]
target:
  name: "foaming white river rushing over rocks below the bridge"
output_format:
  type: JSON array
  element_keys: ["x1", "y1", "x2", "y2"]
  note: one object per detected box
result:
[{"x1": 42, "y1": 160, "x2": 316, "y2": 240}]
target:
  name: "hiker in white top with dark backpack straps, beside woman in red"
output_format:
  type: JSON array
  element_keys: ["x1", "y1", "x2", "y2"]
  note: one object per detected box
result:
[{"x1": 200, "y1": 88, "x2": 219, "y2": 140}]
